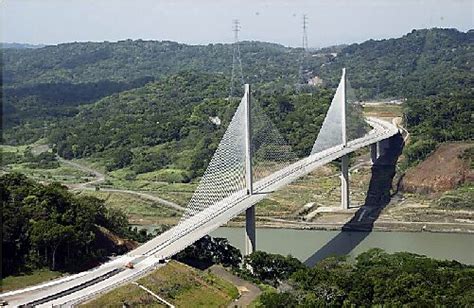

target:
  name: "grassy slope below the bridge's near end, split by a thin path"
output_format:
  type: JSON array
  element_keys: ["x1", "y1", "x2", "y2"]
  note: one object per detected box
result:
[{"x1": 83, "y1": 261, "x2": 238, "y2": 307}]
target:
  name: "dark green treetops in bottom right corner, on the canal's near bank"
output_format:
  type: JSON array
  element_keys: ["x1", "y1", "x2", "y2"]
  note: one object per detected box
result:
[{"x1": 250, "y1": 248, "x2": 474, "y2": 307}]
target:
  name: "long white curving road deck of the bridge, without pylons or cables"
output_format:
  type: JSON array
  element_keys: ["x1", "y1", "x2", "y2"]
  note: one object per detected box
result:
[{"x1": 0, "y1": 118, "x2": 399, "y2": 307}]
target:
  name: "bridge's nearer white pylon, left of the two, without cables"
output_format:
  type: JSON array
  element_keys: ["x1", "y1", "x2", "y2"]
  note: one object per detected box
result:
[{"x1": 244, "y1": 84, "x2": 256, "y2": 255}]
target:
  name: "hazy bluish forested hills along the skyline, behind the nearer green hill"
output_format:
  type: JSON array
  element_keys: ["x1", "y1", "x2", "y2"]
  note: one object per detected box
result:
[{"x1": 1, "y1": 29, "x2": 474, "y2": 147}]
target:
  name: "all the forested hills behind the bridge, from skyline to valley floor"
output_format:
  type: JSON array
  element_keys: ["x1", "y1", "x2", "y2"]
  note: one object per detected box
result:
[{"x1": 2, "y1": 29, "x2": 474, "y2": 179}]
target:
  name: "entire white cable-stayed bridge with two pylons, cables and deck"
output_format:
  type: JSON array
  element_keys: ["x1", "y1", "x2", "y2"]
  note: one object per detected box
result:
[{"x1": 0, "y1": 70, "x2": 399, "y2": 307}]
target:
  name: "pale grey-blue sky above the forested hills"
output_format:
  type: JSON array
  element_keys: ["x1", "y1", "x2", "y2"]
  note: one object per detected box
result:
[{"x1": 0, "y1": 0, "x2": 474, "y2": 48}]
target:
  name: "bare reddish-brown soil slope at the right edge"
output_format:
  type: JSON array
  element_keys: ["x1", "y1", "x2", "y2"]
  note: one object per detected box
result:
[{"x1": 401, "y1": 143, "x2": 474, "y2": 194}]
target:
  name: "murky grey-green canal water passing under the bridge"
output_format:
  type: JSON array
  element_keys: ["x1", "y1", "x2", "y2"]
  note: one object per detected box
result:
[{"x1": 211, "y1": 227, "x2": 474, "y2": 265}]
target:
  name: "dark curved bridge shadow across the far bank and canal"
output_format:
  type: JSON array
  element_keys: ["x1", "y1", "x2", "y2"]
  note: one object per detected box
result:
[{"x1": 304, "y1": 134, "x2": 404, "y2": 266}]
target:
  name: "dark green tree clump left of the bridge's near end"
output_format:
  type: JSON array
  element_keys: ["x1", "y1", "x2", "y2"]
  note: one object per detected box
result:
[{"x1": 0, "y1": 173, "x2": 148, "y2": 277}]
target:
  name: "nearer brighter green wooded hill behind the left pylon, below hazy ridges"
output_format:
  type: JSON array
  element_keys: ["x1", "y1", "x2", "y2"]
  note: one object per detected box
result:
[{"x1": 49, "y1": 73, "x2": 332, "y2": 181}]
